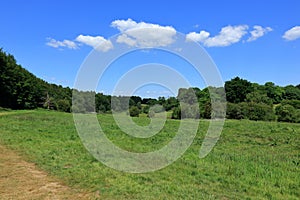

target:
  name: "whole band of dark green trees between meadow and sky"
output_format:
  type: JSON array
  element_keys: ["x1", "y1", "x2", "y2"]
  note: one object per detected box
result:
[{"x1": 0, "y1": 49, "x2": 300, "y2": 123}]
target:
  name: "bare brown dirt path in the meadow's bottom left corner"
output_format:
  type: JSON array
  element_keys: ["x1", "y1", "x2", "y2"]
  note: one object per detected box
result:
[{"x1": 0, "y1": 144, "x2": 96, "y2": 200}]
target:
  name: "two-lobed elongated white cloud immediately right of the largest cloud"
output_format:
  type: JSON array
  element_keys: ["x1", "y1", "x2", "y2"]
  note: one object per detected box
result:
[{"x1": 186, "y1": 25, "x2": 248, "y2": 47}]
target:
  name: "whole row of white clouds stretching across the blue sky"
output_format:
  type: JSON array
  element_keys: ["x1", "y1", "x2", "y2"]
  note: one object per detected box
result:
[{"x1": 46, "y1": 18, "x2": 300, "y2": 52}]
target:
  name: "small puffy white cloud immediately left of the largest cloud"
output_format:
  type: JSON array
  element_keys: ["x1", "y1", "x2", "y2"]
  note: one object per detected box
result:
[{"x1": 76, "y1": 35, "x2": 113, "y2": 52}]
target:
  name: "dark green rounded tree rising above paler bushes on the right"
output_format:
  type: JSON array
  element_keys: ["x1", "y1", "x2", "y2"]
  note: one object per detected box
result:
[{"x1": 225, "y1": 77, "x2": 253, "y2": 103}]
